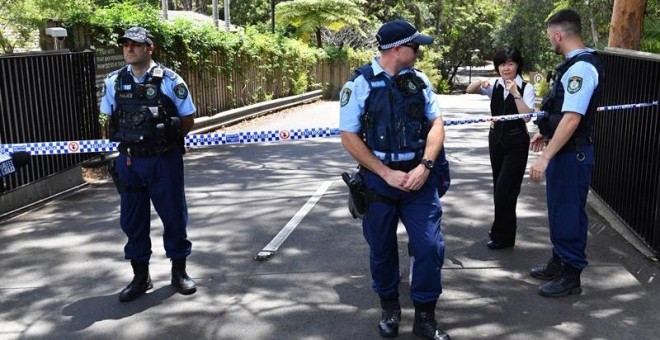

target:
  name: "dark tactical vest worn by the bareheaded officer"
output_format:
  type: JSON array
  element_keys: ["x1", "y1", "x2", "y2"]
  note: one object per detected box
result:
[{"x1": 537, "y1": 51, "x2": 604, "y2": 140}]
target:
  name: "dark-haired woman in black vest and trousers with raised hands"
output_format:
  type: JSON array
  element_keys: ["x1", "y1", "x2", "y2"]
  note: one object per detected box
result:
[{"x1": 466, "y1": 48, "x2": 535, "y2": 249}]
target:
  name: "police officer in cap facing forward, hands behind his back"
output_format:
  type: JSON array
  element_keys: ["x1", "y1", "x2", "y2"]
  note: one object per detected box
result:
[{"x1": 101, "y1": 27, "x2": 197, "y2": 301}]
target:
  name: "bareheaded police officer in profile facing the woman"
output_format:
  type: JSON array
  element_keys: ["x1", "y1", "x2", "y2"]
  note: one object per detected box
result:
[{"x1": 530, "y1": 9, "x2": 603, "y2": 297}]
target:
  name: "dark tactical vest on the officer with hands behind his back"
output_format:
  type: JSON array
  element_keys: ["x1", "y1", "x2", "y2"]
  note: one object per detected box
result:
[{"x1": 111, "y1": 65, "x2": 183, "y2": 157}]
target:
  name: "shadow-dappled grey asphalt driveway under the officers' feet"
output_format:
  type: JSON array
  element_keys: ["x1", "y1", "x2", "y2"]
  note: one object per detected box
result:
[{"x1": 0, "y1": 95, "x2": 660, "y2": 340}]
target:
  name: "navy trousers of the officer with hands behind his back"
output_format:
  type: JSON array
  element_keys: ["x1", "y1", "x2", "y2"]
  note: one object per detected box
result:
[{"x1": 116, "y1": 149, "x2": 192, "y2": 263}]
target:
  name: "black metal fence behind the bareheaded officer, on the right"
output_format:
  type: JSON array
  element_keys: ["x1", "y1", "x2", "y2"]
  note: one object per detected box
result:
[{"x1": 591, "y1": 50, "x2": 660, "y2": 255}]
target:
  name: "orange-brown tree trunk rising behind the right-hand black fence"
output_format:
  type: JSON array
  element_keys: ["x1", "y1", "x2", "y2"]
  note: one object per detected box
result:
[{"x1": 607, "y1": 0, "x2": 646, "y2": 50}]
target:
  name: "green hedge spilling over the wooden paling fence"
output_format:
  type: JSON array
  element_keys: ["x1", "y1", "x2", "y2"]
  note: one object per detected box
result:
[{"x1": 39, "y1": 0, "x2": 360, "y2": 100}]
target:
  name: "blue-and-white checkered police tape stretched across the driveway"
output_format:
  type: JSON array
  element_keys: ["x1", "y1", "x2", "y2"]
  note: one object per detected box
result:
[{"x1": 0, "y1": 101, "x2": 658, "y2": 155}]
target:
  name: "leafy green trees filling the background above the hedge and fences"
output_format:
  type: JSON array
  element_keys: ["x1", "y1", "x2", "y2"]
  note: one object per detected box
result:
[{"x1": 0, "y1": 0, "x2": 660, "y2": 90}]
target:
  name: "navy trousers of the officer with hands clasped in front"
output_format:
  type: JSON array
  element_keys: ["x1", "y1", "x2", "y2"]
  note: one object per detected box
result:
[{"x1": 362, "y1": 169, "x2": 445, "y2": 303}]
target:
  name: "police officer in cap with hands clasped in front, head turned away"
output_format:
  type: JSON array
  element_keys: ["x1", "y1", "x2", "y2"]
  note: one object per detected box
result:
[{"x1": 340, "y1": 20, "x2": 449, "y2": 339}]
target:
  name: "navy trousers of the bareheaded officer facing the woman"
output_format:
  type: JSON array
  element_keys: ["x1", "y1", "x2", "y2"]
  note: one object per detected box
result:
[{"x1": 546, "y1": 145, "x2": 594, "y2": 269}]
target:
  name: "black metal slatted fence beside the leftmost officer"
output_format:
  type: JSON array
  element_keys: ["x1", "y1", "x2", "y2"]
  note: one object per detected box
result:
[{"x1": 0, "y1": 52, "x2": 100, "y2": 191}]
